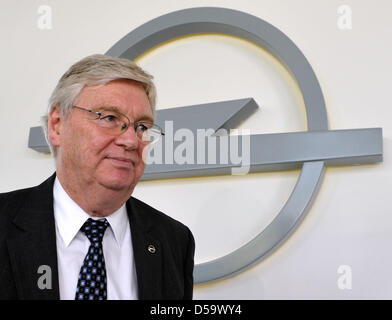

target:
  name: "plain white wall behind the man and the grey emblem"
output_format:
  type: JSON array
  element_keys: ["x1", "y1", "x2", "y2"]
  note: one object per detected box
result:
[{"x1": 0, "y1": 0, "x2": 392, "y2": 299}]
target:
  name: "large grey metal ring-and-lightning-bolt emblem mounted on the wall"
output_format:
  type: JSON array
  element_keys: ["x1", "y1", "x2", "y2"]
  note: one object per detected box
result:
[{"x1": 29, "y1": 7, "x2": 382, "y2": 283}]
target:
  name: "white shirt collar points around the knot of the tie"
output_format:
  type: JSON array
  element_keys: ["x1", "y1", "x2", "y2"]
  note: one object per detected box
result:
[{"x1": 53, "y1": 177, "x2": 129, "y2": 247}]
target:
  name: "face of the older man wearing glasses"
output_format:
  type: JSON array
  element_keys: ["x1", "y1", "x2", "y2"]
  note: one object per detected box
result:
[{"x1": 53, "y1": 80, "x2": 153, "y2": 193}]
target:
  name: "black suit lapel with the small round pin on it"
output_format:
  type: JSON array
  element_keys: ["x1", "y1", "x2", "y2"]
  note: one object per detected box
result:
[{"x1": 127, "y1": 198, "x2": 162, "y2": 300}]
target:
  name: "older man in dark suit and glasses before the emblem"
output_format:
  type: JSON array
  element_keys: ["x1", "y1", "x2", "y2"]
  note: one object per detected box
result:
[{"x1": 0, "y1": 55, "x2": 194, "y2": 300}]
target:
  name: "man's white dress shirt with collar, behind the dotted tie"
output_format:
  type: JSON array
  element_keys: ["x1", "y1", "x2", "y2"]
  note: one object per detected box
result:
[{"x1": 53, "y1": 177, "x2": 138, "y2": 300}]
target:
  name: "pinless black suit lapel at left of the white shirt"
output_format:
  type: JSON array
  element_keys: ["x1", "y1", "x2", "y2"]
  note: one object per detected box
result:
[{"x1": 7, "y1": 175, "x2": 59, "y2": 300}]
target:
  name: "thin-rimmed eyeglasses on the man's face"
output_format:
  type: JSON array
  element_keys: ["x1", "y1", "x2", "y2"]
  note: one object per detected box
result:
[{"x1": 73, "y1": 106, "x2": 165, "y2": 143}]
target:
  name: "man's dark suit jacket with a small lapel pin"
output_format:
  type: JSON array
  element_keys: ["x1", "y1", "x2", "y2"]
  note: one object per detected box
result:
[{"x1": 0, "y1": 174, "x2": 195, "y2": 300}]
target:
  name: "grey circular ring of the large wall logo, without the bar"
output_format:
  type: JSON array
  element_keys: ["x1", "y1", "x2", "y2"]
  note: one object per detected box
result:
[{"x1": 106, "y1": 7, "x2": 328, "y2": 283}]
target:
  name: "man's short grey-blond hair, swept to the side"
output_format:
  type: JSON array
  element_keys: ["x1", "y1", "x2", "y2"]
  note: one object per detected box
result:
[{"x1": 42, "y1": 54, "x2": 156, "y2": 156}]
